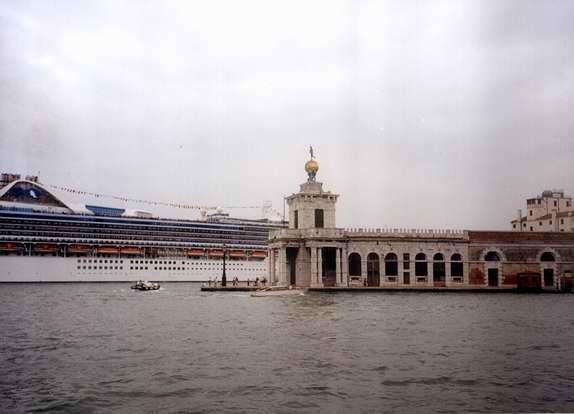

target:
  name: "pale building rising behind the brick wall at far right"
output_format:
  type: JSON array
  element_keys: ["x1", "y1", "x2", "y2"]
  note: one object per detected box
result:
[{"x1": 510, "y1": 190, "x2": 574, "y2": 232}]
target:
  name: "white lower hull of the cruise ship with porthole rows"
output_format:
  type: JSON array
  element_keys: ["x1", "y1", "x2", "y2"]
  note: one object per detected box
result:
[{"x1": 0, "y1": 256, "x2": 267, "y2": 283}]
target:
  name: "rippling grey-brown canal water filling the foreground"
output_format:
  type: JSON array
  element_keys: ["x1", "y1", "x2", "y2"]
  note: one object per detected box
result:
[{"x1": 0, "y1": 283, "x2": 574, "y2": 413}]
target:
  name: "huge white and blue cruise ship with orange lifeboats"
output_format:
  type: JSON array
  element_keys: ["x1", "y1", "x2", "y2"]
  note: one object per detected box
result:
[{"x1": 0, "y1": 174, "x2": 285, "y2": 282}]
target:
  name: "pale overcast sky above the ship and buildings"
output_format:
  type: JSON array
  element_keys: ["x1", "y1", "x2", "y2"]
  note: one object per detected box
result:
[{"x1": 0, "y1": 0, "x2": 574, "y2": 229}]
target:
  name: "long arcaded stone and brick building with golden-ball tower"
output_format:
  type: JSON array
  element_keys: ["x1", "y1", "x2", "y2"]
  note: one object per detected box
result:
[{"x1": 269, "y1": 154, "x2": 574, "y2": 290}]
